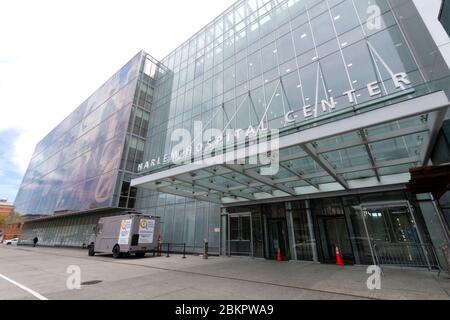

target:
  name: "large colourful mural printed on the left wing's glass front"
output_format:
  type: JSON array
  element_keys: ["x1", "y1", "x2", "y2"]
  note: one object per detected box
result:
[{"x1": 16, "y1": 53, "x2": 142, "y2": 214}]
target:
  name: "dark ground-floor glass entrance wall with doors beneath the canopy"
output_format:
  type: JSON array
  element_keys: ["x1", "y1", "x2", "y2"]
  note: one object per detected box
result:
[{"x1": 224, "y1": 191, "x2": 444, "y2": 267}]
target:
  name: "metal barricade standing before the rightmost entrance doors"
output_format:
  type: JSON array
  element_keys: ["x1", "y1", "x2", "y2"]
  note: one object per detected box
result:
[{"x1": 373, "y1": 242, "x2": 442, "y2": 271}]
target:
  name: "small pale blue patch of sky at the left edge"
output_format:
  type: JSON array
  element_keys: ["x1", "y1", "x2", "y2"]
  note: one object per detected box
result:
[{"x1": 0, "y1": 129, "x2": 22, "y2": 202}]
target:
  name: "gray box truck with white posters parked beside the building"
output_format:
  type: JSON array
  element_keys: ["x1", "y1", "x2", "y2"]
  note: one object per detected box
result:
[{"x1": 88, "y1": 212, "x2": 160, "y2": 259}]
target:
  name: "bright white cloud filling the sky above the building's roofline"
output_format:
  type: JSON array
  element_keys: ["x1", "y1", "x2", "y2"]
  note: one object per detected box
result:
[{"x1": 0, "y1": 0, "x2": 234, "y2": 172}]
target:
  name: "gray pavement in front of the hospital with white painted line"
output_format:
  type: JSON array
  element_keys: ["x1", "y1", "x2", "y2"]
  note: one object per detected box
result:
[{"x1": 0, "y1": 245, "x2": 450, "y2": 300}]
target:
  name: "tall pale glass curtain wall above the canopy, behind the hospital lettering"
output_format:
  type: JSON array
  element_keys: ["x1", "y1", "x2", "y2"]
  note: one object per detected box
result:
[{"x1": 145, "y1": 0, "x2": 423, "y2": 169}]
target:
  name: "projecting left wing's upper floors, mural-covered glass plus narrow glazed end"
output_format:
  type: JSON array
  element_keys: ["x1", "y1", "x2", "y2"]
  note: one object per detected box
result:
[{"x1": 15, "y1": 53, "x2": 165, "y2": 218}]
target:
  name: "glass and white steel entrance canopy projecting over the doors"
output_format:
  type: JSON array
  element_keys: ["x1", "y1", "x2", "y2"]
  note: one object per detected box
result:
[{"x1": 131, "y1": 91, "x2": 449, "y2": 204}]
